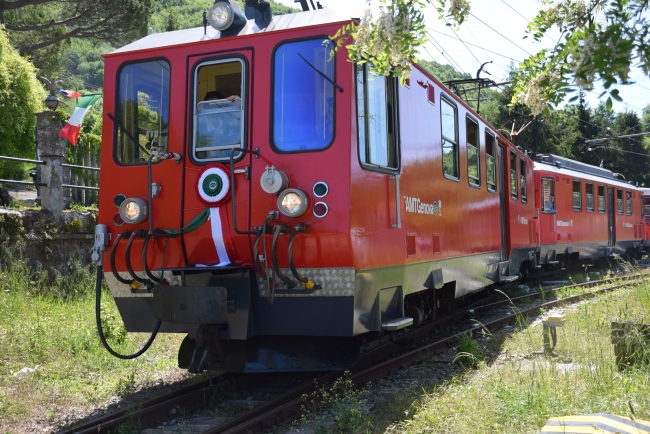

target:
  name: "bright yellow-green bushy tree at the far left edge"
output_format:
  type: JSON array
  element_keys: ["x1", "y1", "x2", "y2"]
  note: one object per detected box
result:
[{"x1": 0, "y1": 26, "x2": 45, "y2": 178}]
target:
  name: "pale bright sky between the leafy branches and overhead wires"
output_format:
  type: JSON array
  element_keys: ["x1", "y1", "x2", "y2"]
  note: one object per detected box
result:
[{"x1": 279, "y1": 0, "x2": 650, "y2": 116}]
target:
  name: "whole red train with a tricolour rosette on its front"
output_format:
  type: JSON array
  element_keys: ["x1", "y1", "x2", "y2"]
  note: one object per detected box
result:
[{"x1": 94, "y1": 1, "x2": 644, "y2": 372}]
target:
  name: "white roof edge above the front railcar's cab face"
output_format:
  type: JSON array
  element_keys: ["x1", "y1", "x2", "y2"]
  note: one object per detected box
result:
[{"x1": 109, "y1": 9, "x2": 352, "y2": 55}]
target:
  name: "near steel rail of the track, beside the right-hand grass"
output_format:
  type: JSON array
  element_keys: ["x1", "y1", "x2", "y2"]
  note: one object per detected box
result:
[{"x1": 203, "y1": 278, "x2": 644, "y2": 434}]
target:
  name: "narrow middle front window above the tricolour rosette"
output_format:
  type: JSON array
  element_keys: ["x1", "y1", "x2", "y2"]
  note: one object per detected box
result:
[{"x1": 192, "y1": 59, "x2": 245, "y2": 162}]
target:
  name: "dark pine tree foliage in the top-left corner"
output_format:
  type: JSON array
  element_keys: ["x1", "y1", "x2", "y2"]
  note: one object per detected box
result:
[{"x1": 0, "y1": 0, "x2": 151, "y2": 72}]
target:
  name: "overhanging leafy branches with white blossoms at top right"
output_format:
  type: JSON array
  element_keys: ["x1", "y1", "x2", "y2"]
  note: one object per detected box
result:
[{"x1": 333, "y1": 0, "x2": 650, "y2": 116}]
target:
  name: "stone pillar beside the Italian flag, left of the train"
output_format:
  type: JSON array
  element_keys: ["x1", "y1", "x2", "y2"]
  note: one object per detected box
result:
[{"x1": 36, "y1": 112, "x2": 68, "y2": 216}]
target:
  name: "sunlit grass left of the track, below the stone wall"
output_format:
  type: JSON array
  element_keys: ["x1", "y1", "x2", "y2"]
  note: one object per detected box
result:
[{"x1": 0, "y1": 244, "x2": 185, "y2": 433}]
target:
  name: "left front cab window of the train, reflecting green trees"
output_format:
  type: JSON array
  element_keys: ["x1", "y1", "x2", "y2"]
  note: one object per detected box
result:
[{"x1": 114, "y1": 59, "x2": 170, "y2": 165}]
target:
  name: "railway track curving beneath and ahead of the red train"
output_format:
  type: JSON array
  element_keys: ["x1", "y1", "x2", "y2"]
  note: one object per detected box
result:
[{"x1": 60, "y1": 273, "x2": 647, "y2": 434}]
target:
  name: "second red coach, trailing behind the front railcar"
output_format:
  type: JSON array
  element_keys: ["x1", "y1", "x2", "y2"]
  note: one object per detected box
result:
[{"x1": 535, "y1": 155, "x2": 645, "y2": 265}]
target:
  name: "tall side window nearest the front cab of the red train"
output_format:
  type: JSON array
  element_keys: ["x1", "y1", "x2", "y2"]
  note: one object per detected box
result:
[{"x1": 357, "y1": 63, "x2": 399, "y2": 170}]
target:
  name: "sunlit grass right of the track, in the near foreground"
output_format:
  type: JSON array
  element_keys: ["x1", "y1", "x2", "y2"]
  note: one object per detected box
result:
[{"x1": 298, "y1": 274, "x2": 650, "y2": 434}]
